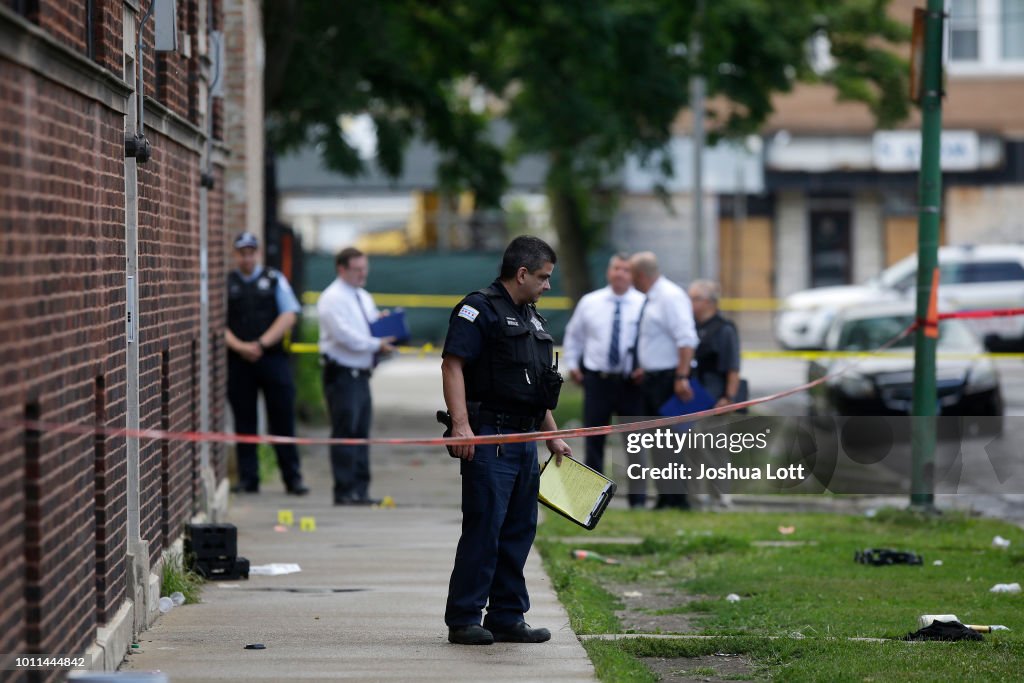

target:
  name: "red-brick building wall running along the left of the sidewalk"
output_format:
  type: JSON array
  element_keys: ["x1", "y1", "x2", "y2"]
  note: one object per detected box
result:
[{"x1": 0, "y1": 0, "x2": 260, "y2": 680}]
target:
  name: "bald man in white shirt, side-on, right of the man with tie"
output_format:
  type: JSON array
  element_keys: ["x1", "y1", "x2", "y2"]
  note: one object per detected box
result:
[{"x1": 630, "y1": 252, "x2": 699, "y2": 510}]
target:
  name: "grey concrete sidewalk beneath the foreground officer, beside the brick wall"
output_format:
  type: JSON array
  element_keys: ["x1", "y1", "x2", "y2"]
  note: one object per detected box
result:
[{"x1": 122, "y1": 364, "x2": 594, "y2": 682}]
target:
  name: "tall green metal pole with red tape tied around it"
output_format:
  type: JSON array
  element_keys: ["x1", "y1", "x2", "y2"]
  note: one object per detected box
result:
[{"x1": 910, "y1": 0, "x2": 943, "y2": 509}]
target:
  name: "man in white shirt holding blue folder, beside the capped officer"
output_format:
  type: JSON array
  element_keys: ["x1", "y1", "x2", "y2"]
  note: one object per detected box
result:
[{"x1": 316, "y1": 247, "x2": 394, "y2": 505}]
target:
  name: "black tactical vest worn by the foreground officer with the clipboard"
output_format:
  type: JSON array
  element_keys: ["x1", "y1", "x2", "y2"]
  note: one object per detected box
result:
[{"x1": 464, "y1": 285, "x2": 562, "y2": 416}]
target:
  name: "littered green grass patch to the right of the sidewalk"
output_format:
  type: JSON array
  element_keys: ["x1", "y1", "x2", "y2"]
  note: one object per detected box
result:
[{"x1": 539, "y1": 510, "x2": 1024, "y2": 681}]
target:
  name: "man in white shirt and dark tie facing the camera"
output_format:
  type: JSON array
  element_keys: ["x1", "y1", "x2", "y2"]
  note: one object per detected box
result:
[{"x1": 562, "y1": 254, "x2": 646, "y2": 508}]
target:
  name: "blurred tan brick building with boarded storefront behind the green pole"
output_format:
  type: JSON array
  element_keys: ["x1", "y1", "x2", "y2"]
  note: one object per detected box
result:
[{"x1": 761, "y1": 0, "x2": 1024, "y2": 296}]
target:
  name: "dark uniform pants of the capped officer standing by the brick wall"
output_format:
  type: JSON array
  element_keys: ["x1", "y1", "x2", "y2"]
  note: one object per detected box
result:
[{"x1": 227, "y1": 352, "x2": 302, "y2": 490}]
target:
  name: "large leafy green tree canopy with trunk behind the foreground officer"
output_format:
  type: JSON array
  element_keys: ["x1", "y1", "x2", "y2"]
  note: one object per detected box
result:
[{"x1": 266, "y1": 0, "x2": 907, "y2": 298}]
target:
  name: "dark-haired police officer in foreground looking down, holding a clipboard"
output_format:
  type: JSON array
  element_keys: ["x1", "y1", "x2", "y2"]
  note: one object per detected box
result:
[{"x1": 441, "y1": 237, "x2": 572, "y2": 645}]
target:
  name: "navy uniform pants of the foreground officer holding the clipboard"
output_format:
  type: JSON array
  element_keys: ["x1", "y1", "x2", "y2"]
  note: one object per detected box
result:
[{"x1": 444, "y1": 426, "x2": 540, "y2": 631}]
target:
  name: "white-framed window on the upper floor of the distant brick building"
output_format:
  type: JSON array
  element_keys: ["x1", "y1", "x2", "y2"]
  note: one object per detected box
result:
[{"x1": 947, "y1": 0, "x2": 1024, "y2": 76}]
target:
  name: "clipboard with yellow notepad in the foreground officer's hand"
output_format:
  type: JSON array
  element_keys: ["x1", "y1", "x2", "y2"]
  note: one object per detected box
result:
[{"x1": 538, "y1": 456, "x2": 615, "y2": 530}]
